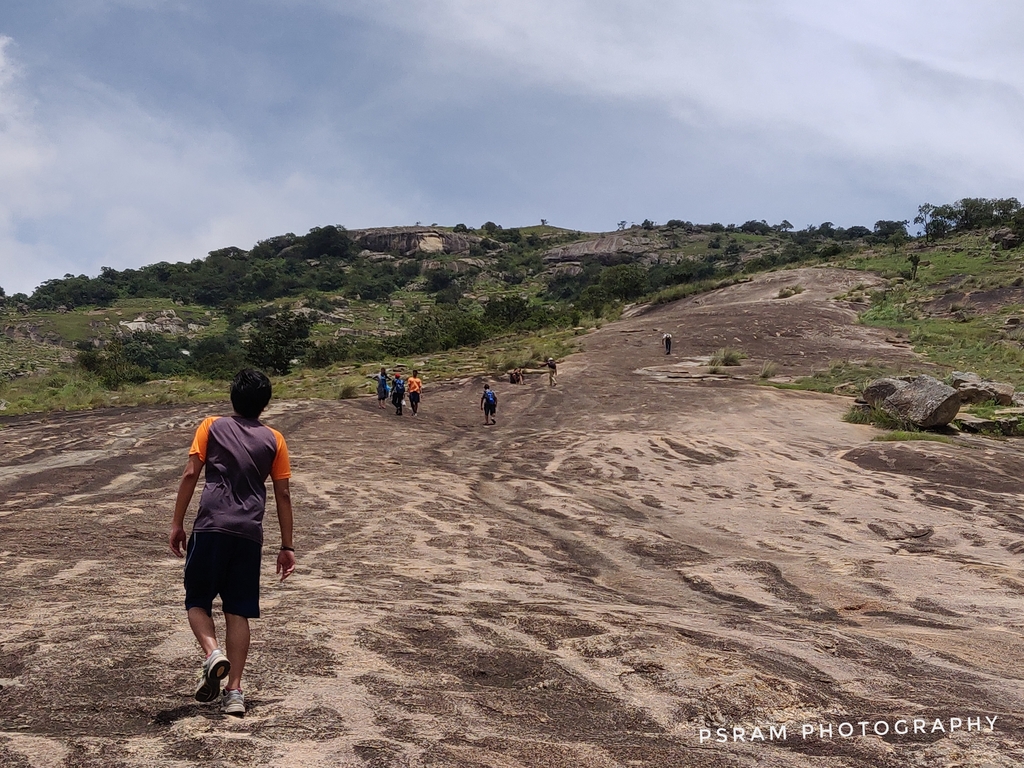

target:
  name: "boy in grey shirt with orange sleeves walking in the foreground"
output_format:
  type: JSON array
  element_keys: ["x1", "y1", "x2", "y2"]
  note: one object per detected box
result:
[{"x1": 169, "y1": 369, "x2": 295, "y2": 717}]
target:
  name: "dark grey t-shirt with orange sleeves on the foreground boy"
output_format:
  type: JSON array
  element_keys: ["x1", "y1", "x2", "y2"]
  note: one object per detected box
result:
[{"x1": 188, "y1": 416, "x2": 292, "y2": 544}]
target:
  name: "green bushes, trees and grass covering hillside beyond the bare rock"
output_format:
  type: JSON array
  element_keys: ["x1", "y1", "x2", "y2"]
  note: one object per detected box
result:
[{"x1": 0, "y1": 199, "x2": 1024, "y2": 410}]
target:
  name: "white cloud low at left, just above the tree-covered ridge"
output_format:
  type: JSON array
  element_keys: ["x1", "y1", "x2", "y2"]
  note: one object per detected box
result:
[{"x1": 0, "y1": 33, "x2": 404, "y2": 294}]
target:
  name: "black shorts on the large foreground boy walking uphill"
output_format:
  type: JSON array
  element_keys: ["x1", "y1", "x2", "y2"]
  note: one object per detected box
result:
[{"x1": 185, "y1": 530, "x2": 263, "y2": 618}]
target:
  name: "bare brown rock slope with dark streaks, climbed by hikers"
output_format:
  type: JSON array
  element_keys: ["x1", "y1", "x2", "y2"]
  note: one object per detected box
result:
[{"x1": 0, "y1": 269, "x2": 1024, "y2": 768}]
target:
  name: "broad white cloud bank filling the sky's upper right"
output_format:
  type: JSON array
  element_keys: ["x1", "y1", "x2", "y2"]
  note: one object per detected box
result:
[{"x1": 348, "y1": 0, "x2": 1024, "y2": 194}]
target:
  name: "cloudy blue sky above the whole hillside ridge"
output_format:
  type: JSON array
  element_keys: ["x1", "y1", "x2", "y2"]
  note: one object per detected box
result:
[{"x1": 0, "y1": 0, "x2": 1024, "y2": 295}]
